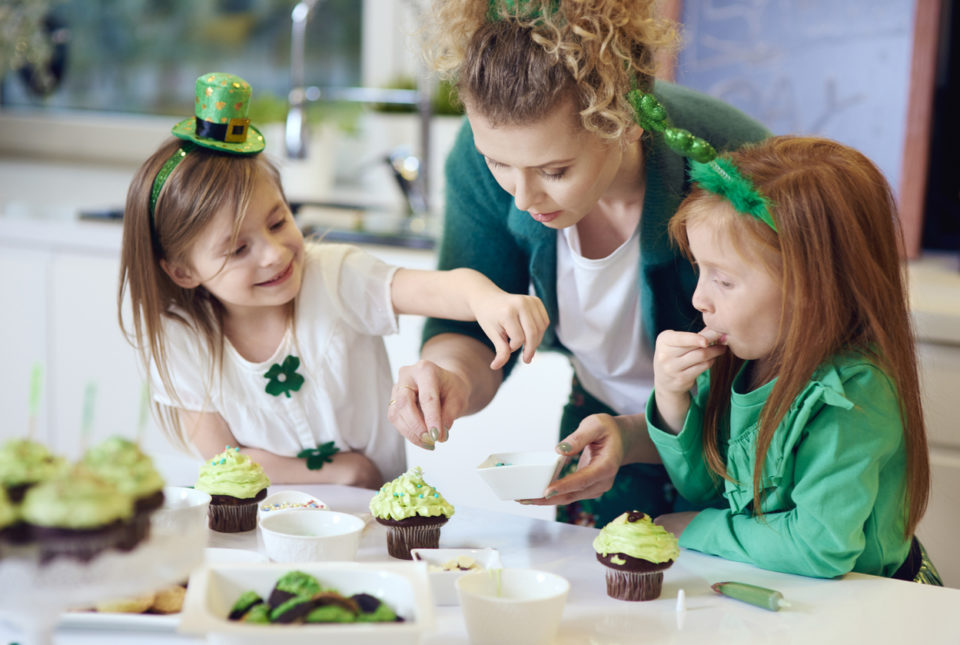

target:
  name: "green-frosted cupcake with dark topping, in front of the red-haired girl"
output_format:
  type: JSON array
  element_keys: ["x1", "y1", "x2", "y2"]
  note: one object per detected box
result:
[{"x1": 593, "y1": 511, "x2": 680, "y2": 600}]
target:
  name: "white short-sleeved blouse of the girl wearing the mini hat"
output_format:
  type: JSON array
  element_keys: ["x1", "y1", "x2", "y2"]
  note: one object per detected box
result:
[{"x1": 151, "y1": 243, "x2": 406, "y2": 480}]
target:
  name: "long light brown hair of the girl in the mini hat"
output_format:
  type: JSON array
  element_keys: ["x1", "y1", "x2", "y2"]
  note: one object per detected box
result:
[{"x1": 117, "y1": 138, "x2": 283, "y2": 446}]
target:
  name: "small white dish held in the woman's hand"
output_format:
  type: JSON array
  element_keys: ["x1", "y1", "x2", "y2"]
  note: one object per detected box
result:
[{"x1": 477, "y1": 450, "x2": 566, "y2": 499}]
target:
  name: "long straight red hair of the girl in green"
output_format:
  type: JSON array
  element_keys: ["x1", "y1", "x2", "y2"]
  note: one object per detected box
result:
[{"x1": 669, "y1": 137, "x2": 930, "y2": 536}]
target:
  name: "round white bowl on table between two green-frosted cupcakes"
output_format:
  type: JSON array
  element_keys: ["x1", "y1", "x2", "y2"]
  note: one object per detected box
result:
[{"x1": 260, "y1": 509, "x2": 365, "y2": 562}]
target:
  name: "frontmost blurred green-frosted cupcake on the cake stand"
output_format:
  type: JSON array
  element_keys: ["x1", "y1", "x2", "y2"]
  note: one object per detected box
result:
[{"x1": 20, "y1": 465, "x2": 133, "y2": 562}]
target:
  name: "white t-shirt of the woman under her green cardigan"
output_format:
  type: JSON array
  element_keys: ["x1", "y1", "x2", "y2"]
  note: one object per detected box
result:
[{"x1": 556, "y1": 226, "x2": 653, "y2": 414}]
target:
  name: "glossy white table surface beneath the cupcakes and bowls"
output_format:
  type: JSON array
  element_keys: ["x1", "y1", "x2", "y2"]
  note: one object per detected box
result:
[{"x1": 0, "y1": 486, "x2": 960, "y2": 645}]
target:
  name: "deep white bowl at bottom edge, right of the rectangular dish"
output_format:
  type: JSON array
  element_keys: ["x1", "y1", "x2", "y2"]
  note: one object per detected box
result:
[{"x1": 455, "y1": 569, "x2": 570, "y2": 645}]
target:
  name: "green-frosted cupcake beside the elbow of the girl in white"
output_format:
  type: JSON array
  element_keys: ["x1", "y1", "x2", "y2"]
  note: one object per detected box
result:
[{"x1": 194, "y1": 446, "x2": 270, "y2": 533}]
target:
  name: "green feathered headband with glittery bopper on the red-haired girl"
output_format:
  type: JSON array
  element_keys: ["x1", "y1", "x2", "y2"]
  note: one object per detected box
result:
[{"x1": 627, "y1": 89, "x2": 777, "y2": 232}]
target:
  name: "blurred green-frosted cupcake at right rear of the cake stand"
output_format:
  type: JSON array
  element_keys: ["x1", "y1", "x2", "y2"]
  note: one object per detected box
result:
[{"x1": 83, "y1": 437, "x2": 164, "y2": 548}]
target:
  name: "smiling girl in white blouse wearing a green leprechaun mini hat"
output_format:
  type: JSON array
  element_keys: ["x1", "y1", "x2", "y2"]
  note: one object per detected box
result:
[{"x1": 118, "y1": 73, "x2": 548, "y2": 488}]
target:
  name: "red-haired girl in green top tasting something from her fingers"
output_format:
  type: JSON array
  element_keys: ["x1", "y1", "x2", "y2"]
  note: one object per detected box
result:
[{"x1": 553, "y1": 137, "x2": 941, "y2": 584}]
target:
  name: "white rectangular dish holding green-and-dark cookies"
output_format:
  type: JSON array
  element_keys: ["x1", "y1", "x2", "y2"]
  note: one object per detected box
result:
[{"x1": 179, "y1": 560, "x2": 434, "y2": 645}]
